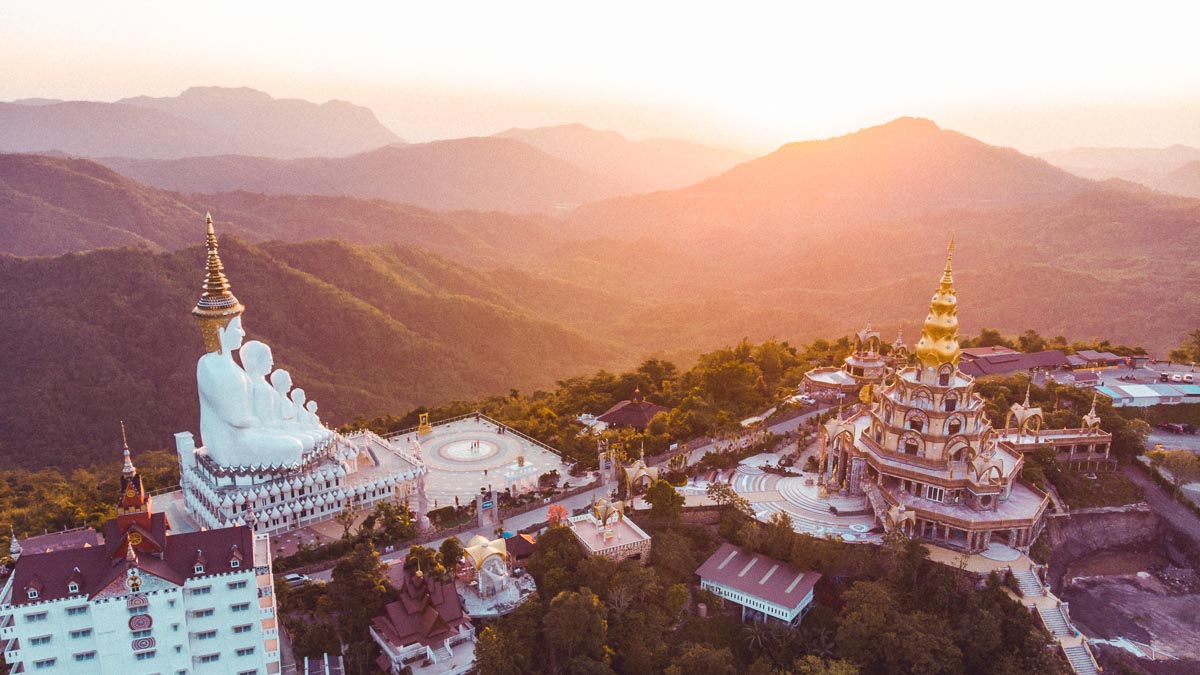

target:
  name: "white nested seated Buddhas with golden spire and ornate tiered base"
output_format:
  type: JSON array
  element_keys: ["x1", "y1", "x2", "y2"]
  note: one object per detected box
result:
[{"x1": 175, "y1": 216, "x2": 427, "y2": 533}]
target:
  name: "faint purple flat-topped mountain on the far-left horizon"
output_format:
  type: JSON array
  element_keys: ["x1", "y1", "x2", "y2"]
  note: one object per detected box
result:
[{"x1": 0, "y1": 86, "x2": 401, "y2": 159}]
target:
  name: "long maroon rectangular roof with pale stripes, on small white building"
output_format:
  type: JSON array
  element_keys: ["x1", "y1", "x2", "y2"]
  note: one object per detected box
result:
[{"x1": 696, "y1": 544, "x2": 821, "y2": 608}]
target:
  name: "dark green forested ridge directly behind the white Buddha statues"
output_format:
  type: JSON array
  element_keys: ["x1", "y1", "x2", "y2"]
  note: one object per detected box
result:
[{"x1": 0, "y1": 237, "x2": 617, "y2": 466}]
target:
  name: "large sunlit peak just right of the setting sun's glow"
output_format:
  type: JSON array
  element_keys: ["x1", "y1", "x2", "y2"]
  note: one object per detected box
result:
[{"x1": 566, "y1": 118, "x2": 1091, "y2": 239}]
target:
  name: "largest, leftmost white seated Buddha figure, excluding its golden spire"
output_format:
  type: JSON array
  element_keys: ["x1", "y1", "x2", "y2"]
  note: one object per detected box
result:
[{"x1": 196, "y1": 316, "x2": 304, "y2": 466}]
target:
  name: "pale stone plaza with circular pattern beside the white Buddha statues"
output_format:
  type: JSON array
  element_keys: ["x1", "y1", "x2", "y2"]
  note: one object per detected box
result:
[{"x1": 398, "y1": 414, "x2": 568, "y2": 508}]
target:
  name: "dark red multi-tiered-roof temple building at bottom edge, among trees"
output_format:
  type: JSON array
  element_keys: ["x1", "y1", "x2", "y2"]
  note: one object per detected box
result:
[{"x1": 371, "y1": 572, "x2": 475, "y2": 675}]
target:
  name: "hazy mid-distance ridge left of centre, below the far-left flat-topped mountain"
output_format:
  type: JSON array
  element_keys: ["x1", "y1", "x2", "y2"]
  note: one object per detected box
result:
[{"x1": 100, "y1": 138, "x2": 632, "y2": 213}]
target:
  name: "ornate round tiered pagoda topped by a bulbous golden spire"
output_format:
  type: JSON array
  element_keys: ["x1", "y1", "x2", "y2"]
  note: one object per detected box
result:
[{"x1": 820, "y1": 241, "x2": 1111, "y2": 552}]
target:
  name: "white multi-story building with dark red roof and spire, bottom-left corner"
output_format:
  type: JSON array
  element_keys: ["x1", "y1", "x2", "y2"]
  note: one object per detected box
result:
[{"x1": 0, "y1": 448, "x2": 280, "y2": 675}]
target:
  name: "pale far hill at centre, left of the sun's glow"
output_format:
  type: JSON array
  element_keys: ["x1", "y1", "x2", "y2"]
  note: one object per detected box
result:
[{"x1": 496, "y1": 124, "x2": 751, "y2": 192}]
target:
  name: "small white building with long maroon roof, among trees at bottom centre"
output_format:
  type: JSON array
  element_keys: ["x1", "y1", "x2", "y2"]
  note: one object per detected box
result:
[{"x1": 696, "y1": 544, "x2": 821, "y2": 626}]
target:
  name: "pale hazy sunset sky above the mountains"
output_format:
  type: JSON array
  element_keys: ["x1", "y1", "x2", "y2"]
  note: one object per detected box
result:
[{"x1": 0, "y1": 0, "x2": 1200, "y2": 151}]
